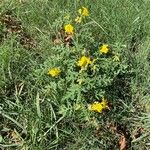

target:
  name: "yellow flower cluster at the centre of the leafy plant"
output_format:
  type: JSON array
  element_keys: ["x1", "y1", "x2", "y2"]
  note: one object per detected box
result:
[{"x1": 77, "y1": 56, "x2": 92, "y2": 68}]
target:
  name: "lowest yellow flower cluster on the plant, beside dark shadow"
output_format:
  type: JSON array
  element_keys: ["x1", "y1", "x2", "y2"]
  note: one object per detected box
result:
[{"x1": 88, "y1": 98, "x2": 109, "y2": 113}]
